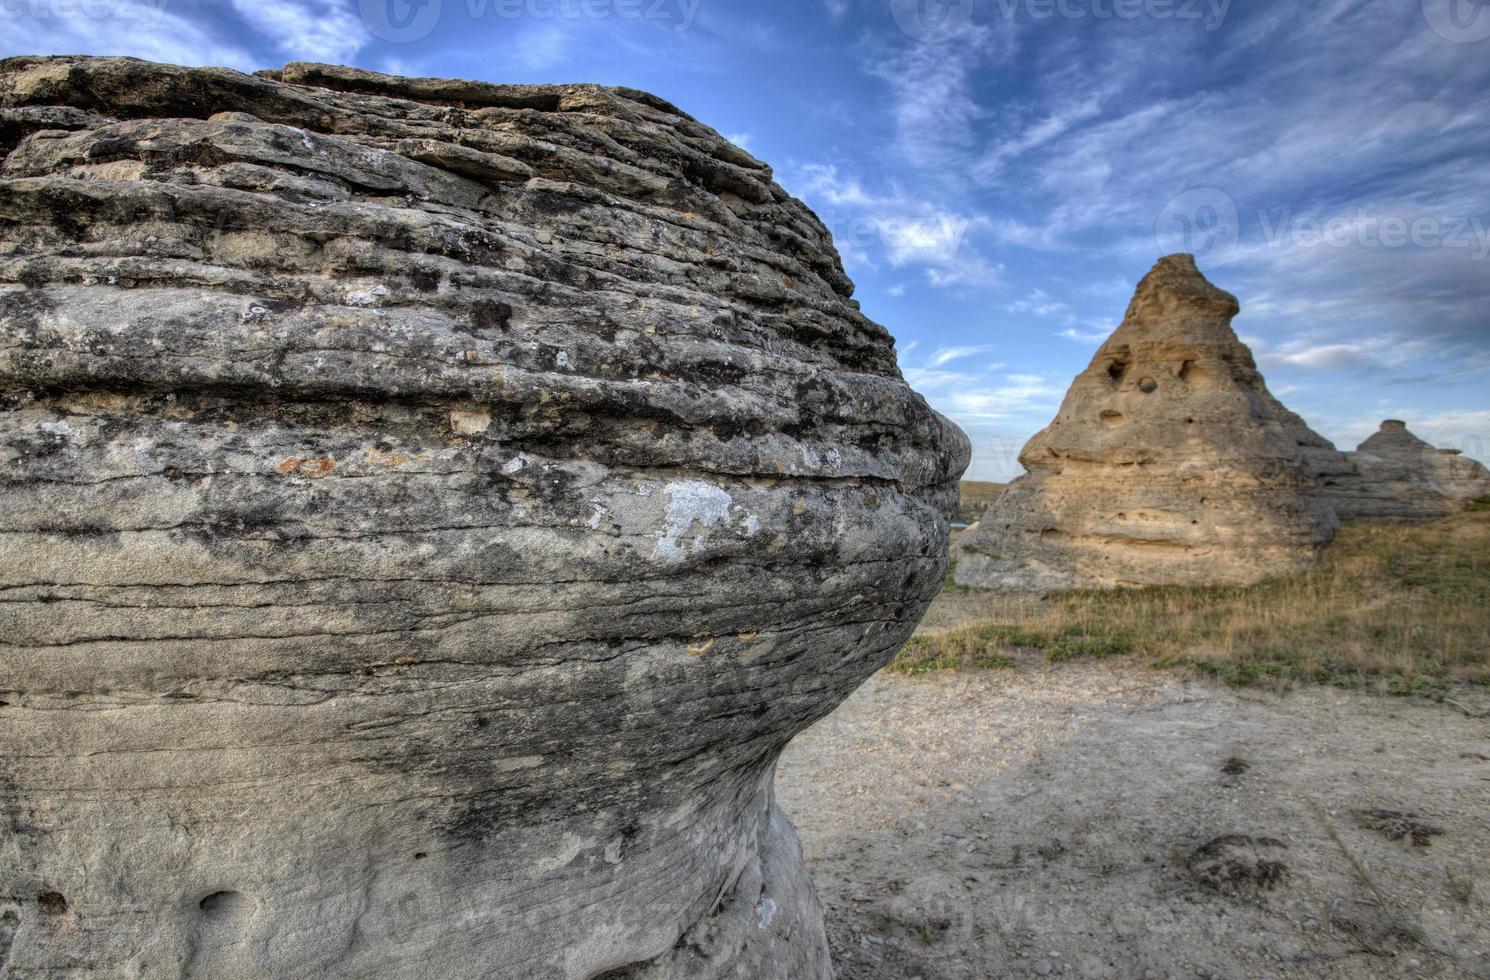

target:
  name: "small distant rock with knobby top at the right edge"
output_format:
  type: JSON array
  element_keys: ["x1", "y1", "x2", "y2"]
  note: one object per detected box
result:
[{"x1": 1325, "y1": 419, "x2": 1490, "y2": 521}]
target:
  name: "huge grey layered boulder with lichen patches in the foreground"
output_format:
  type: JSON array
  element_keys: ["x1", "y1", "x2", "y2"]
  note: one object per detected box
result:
[{"x1": 0, "y1": 58, "x2": 967, "y2": 980}]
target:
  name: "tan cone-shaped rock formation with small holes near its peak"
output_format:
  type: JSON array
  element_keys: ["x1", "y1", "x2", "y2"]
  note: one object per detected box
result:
[{"x1": 957, "y1": 255, "x2": 1350, "y2": 590}]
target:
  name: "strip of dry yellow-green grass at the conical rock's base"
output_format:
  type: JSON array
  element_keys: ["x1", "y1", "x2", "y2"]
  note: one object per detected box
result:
[{"x1": 891, "y1": 512, "x2": 1490, "y2": 697}]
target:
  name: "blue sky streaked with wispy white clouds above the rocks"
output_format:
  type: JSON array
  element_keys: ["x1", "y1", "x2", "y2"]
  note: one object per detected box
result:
[{"x1": 0, "y1": 0, "x2": 1490, "y2": 480}]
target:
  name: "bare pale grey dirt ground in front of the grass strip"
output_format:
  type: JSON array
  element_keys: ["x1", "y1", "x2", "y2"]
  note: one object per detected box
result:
[{"x1": 778, "y1": 661, "x2": 1490, "y2": 980}]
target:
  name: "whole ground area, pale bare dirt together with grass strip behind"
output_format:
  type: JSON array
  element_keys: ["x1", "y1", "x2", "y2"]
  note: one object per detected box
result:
[{"x1": 776, "y1": 506, "x2": 1490, "y2": 980}]
